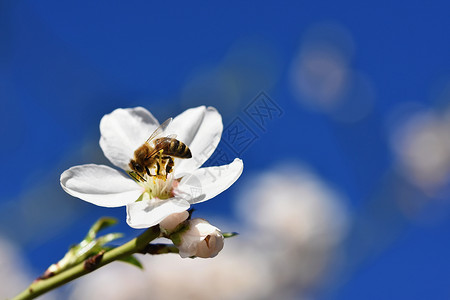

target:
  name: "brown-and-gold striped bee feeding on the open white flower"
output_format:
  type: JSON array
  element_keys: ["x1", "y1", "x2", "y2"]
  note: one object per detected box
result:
[{"x1": 128, "y1": 118, "x2": 192, "y2": 181}]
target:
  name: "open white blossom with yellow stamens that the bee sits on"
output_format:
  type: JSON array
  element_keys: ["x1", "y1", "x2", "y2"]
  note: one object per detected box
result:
[{"x1": 60, "y1": 106, "x2": 243, "y2": 228}]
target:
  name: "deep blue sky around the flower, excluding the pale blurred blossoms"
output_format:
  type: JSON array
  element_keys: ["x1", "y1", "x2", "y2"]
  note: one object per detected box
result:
[{"x1": 0, "y1": 0, "x2": 450, "y2": 299}]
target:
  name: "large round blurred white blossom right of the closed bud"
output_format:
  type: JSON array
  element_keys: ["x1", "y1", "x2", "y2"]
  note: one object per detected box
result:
[{"x1": 239, "y1": 167, "x2": 348, "y2": 293}]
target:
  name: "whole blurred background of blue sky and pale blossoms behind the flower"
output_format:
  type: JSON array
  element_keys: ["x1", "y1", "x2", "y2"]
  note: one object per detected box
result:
[{"x1": 0, "y1": 0, "x2": 450, "y2": 299}]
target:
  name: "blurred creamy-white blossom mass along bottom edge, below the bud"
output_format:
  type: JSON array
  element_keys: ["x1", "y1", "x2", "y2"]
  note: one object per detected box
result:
[{"x1": 70, "y1": 240, "x2": 273, "y2": 300}]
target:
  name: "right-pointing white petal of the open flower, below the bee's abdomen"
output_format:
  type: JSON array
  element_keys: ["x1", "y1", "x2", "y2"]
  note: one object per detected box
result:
[{"x1": 176, "y1": 158, "x2": 244, "y2": 204}]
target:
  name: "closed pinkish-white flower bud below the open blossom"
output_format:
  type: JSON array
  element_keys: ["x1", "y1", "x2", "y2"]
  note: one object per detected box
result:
[{"x1": 172, "y1": 219, "x2": 224, "y2": 258}]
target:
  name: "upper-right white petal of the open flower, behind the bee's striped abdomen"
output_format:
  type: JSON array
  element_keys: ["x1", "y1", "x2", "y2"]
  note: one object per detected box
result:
[{"x1": 165, "y1": 106, "x2": 223, "y2": 178}]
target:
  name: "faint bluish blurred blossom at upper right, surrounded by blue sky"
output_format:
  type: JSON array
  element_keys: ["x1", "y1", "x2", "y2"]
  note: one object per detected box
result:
[{"x1": 290, "y1": 23, "x2": 374, "y2": 122}]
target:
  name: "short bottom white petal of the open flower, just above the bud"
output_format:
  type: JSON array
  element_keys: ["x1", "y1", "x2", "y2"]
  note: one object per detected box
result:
[{"x1": 127, "y1": 198, "x2": 190, "y2": 228}]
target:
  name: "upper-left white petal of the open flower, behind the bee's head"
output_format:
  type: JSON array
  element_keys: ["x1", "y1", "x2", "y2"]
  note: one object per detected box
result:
[{"x1": 100, "y1": 107, "x2": 159, "y2": 170}]
